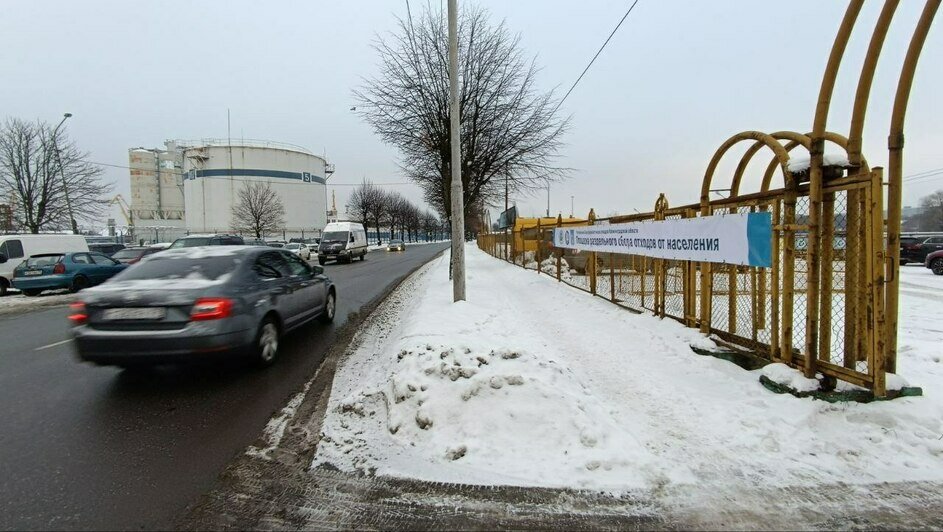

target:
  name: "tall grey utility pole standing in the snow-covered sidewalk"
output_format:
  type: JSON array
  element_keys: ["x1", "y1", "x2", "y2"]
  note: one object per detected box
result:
[{"x1": 449, "y1": 0, "x2": 465, "y2": 301}]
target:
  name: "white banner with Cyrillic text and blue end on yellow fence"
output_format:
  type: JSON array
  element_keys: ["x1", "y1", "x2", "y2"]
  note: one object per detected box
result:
[{"x1": 553, "y1": 212, "x2": 773, "y2": 268}]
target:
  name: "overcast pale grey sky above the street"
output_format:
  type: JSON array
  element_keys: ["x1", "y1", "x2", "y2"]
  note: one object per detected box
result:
[{"x1": 0, "y1": 0, "x2": 943, "y2": 224}]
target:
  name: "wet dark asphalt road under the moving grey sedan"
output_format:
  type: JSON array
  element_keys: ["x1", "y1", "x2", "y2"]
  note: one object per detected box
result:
[{"x1": 0, "y1": 244, "x2": 447, "y2": 529}]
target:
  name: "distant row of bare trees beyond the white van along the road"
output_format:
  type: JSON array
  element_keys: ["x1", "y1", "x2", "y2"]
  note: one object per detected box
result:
[{"x1": 348, "y1": 180, "x2": 447, "y2": 242}]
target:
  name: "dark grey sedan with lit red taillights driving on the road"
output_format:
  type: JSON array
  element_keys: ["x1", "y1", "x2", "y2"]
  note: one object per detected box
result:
[{"x1": 69, "y1": 246, "x2": 337, "y2": 367}]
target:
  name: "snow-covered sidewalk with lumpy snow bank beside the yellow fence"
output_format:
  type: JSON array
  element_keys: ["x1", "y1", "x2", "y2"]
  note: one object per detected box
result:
[{"x1": 313, "y1": 246, "x2": 943, "y2": 494}]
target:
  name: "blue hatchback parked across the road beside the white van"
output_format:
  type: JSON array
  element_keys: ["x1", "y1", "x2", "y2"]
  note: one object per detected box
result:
[{"x1": 13, "y1": 251, "x2": 128, "y2": 296}]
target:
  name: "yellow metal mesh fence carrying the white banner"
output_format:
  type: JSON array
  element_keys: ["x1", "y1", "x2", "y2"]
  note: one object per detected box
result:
[{"x1": 478, "y1": 172, "x2": 893, "y2": 395}]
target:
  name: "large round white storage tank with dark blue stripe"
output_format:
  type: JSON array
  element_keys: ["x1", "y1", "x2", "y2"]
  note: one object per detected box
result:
[{"x1": 178, "y1": 139, "x2": 333, "y2": 236}]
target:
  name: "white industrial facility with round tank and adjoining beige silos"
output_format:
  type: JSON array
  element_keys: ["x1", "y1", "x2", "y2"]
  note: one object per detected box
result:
[{"x1": 129, "y1": 139, "x2": 333, "y2": 240}]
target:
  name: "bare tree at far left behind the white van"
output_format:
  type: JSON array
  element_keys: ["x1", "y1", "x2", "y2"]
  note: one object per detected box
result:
[{"x1": 0, "y1": 118, "x2": 112, "y2": 233}]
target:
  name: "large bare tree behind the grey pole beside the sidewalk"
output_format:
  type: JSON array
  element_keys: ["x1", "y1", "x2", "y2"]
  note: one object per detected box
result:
[{"x1": 354, "y1": 3, "x2": 567, "y2": 218}]
